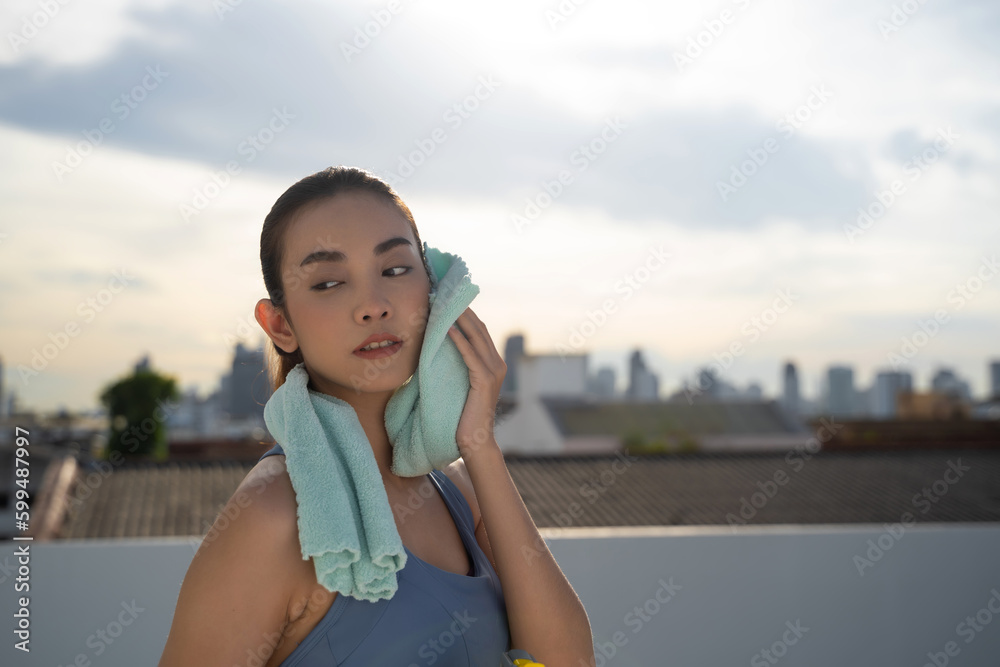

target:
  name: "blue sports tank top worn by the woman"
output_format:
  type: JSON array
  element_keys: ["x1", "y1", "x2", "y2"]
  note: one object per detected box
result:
[{"x1": 258, "y1": 444, "x2": 510, "y2": 667}]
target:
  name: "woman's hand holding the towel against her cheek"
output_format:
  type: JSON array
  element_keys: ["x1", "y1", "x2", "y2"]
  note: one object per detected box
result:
[{"x1": 448, "y1": 308, "x2": 507, "y2": 458}]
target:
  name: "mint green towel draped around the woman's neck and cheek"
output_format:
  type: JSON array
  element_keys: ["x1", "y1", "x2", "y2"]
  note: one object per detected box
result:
[{"x1": 264, "y1": 243, "x2": 479, "y2": 602}]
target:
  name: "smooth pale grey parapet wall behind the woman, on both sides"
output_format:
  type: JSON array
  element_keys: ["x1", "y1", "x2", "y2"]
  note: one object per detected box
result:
[{"x1": 0, "y1": 524, "x2": 1000, "y2": 667}]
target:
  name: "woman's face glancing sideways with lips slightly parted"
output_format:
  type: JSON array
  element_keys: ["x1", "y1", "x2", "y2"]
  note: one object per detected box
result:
[{"x1": 282, "y1": 192, "x2": 431, "y2": 400}]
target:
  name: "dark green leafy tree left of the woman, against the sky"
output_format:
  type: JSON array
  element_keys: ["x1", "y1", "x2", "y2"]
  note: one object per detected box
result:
[{"x1": 101, "y1": 368, "x2": 179, "y2": 461}]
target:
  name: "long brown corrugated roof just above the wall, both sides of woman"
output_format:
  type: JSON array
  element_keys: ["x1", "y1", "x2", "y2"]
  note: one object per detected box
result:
[{"x1": 48, "y1": 449, "x2": 1000, "y2": 538}]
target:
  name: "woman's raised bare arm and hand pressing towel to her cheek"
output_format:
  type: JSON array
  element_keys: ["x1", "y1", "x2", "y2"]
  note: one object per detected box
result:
[{"x1": 449, "y1": 308, "x2": 595, "y2": 667}]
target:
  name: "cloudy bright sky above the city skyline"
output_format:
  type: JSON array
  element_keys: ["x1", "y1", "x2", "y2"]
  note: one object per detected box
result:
[{"x1": 0, "y1": 0, "x2": 1000, "y2": 411}]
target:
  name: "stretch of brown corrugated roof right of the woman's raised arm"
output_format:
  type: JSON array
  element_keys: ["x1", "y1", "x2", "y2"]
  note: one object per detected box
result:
[{"x1": 507, "y1": 449, "x2": 1000, "y2": 527}]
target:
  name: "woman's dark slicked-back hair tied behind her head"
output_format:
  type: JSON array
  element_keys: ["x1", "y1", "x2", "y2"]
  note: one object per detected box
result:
[{"x1": 260, "y1": 166, "x2": 431, "y2": 391}]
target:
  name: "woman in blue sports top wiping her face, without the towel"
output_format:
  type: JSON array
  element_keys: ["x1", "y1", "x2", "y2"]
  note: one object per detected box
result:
[{"x1": 160, "y1": 167, "x2": 594, "y2": 667}]
